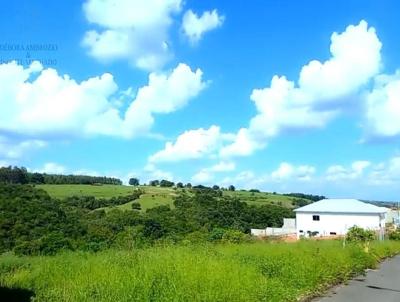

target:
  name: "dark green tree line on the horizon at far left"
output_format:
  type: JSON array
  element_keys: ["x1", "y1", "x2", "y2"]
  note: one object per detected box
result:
[{"x1": 0, "y1": 166, "x2": 122, "y2": 185}]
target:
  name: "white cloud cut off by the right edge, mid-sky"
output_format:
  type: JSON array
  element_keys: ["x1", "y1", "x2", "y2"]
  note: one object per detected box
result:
[{"x1": 365, "y1": 70, "x2": 400, "y2": 139}]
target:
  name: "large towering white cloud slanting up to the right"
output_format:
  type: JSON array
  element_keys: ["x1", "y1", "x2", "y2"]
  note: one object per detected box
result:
[{"x1": 221, "y1": 21, "x2": 382, "y2": 156}]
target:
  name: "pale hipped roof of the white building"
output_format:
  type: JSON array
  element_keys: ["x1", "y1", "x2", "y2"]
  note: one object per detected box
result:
[{"x1": 294, "y1": 199, "x2": 387, "y2": 214}]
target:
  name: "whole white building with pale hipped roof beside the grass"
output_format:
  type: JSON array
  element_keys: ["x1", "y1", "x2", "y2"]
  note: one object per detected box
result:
[{"x1": 294, "y1": 199, "x2": 387, "y2": 237}]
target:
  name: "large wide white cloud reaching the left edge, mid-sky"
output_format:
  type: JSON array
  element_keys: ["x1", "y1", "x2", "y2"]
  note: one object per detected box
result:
[{"x1": 0, "y1": 62, "x2": 206, "y2": 140}]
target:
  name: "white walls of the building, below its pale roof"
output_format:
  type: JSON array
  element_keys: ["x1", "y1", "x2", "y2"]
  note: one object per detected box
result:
[{"x1": 296, "y1": 213, "x2": 386, "y2": 237}]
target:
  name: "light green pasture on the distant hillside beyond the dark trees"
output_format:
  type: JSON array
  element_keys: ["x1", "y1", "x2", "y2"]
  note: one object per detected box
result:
[{"x1": 37, "y1": 185, "x2": 306, "y2": 210}]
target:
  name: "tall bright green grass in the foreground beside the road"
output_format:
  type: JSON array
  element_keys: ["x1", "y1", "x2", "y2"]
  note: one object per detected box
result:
[{"x1": 0, "y1": 241, "x2": 400, "y2": 302}]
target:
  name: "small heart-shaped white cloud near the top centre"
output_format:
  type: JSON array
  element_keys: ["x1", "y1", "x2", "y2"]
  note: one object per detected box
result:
[{"x1": 182, "y1": 9, "x2": 225, "y2": 43}]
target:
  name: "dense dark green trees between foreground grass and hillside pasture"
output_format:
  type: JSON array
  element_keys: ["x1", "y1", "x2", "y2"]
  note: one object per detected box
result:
[{"x1": 0, "y1": 184, "x2": 293, "y2": 254}]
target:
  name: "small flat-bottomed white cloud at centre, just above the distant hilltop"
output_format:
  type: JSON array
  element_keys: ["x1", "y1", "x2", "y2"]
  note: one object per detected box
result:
[{"x1": 149, "y1": 125, "x2": 230, "y2": 162}]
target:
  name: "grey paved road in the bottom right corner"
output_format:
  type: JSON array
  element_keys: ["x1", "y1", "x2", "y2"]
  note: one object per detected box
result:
[{"x1": 313, "y1": 256, "x2": 400, "y2": 302}]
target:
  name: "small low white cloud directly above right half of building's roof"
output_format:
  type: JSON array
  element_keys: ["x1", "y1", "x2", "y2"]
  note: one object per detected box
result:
[{"x1": 326, "y1": 160, "x2": 371, "y2": 181}]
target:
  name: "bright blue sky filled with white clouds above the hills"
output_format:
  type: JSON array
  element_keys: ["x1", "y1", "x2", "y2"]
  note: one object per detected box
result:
[{"x1": 0, "y1": 0, "x2": 400, "y2": 201}]
